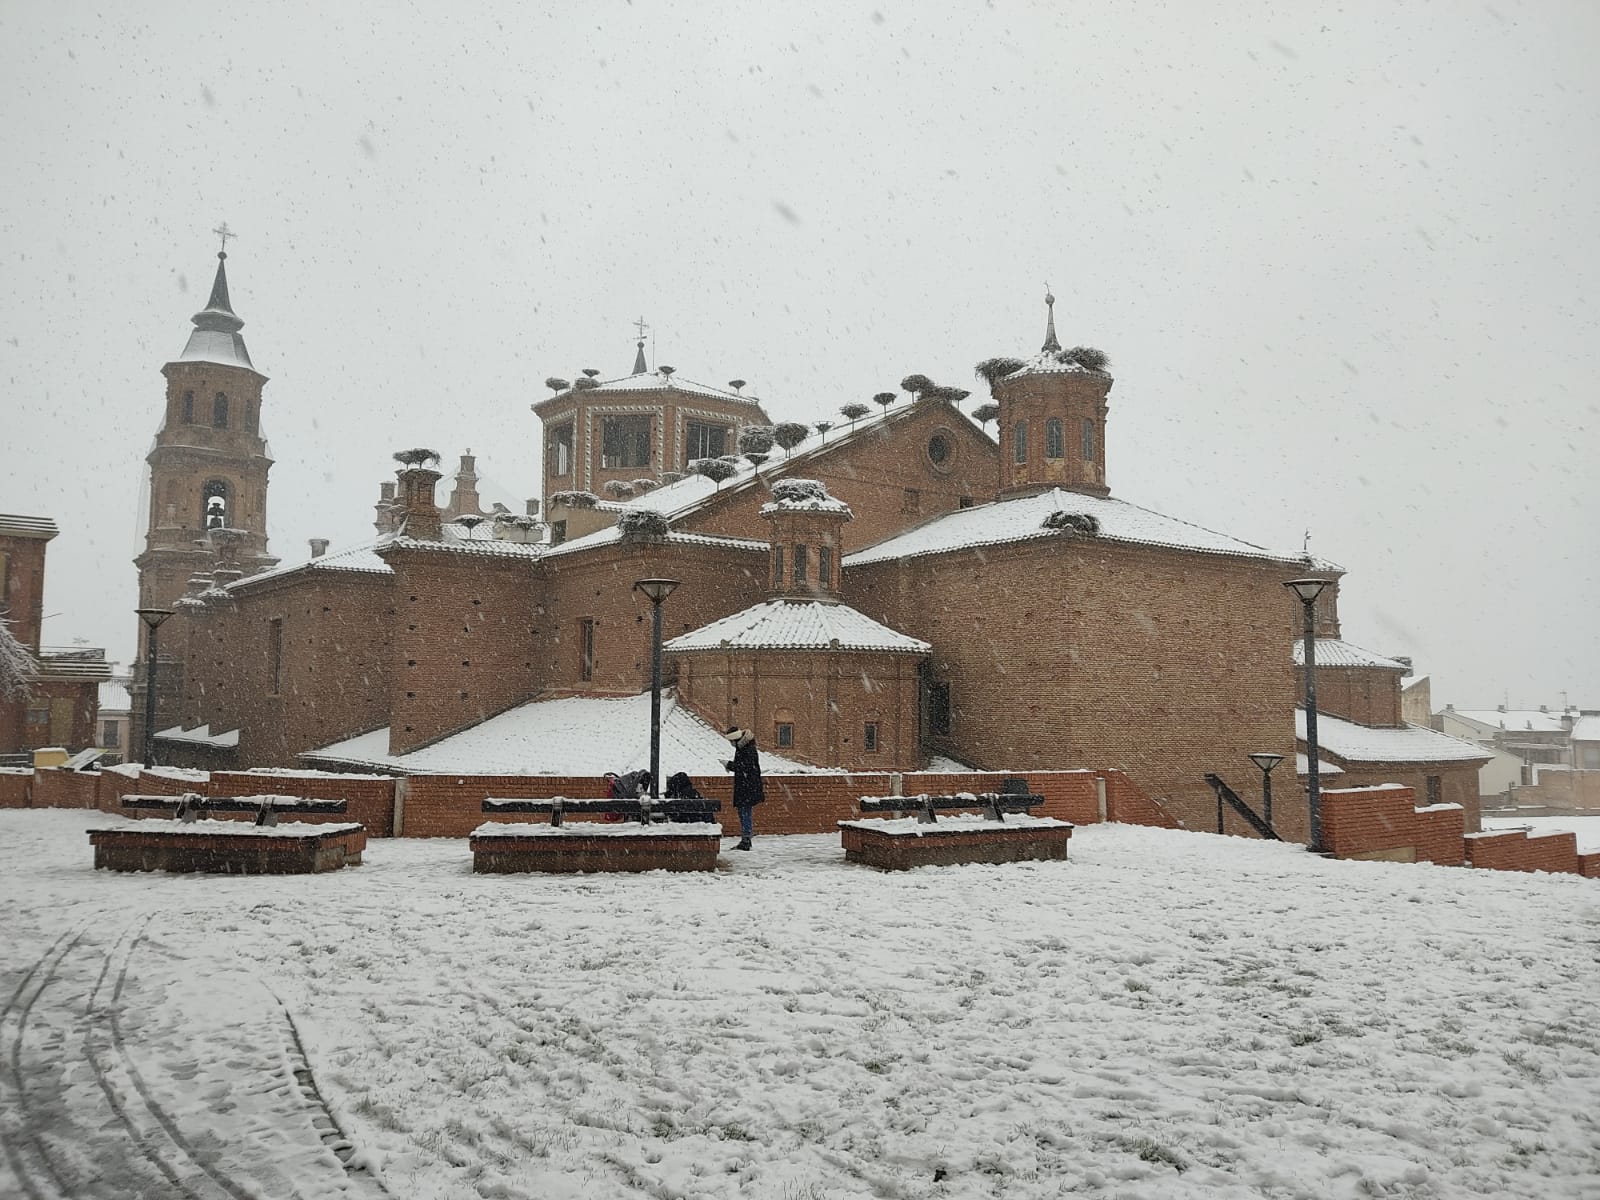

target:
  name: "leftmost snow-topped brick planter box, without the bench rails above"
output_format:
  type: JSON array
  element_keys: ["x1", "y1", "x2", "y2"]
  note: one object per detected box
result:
[{"x1": 90, "y1": 821, "x2": 366, "y2": 875}]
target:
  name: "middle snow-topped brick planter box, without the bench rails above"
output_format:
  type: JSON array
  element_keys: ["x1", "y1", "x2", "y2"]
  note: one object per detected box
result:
[{"x1": 470, "y1": 821, "x2": 722, "y2": 875}]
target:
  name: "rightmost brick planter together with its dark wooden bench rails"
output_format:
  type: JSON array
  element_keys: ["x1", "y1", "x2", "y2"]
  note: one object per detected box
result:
[{"x1": 838, "y1": 792, "x2": 1072, "y2": 870}]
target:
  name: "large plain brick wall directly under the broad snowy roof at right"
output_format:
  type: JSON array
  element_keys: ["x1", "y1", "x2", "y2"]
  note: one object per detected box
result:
[{"x1": 843, "y1": 539, "x2": 1306, "y2": 838}]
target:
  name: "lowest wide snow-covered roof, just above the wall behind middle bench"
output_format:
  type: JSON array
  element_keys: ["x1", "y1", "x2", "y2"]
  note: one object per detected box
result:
[{"x1": 301, "y1": 691, "x2": 818, "y2": 778}]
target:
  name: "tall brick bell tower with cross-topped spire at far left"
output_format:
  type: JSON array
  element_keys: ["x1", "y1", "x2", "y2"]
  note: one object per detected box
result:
[{"x1": 133, "y1": 244, "x2": 277, "y2": 746}]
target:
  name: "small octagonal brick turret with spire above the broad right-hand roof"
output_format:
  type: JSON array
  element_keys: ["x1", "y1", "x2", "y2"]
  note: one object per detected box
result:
[{"x1": 990, "y1": 294, "x2": 1112, "y2": 496}]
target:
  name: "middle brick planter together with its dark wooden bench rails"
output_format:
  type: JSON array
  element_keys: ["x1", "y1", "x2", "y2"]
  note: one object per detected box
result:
[{"x1": 470, "y1": 795, "x2": 722, "y2": 874}]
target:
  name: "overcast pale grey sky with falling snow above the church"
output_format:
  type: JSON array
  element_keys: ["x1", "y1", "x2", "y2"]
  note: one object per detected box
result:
[{"x1": 0, "y1": 0, "x2": 1600, "y2": 707}]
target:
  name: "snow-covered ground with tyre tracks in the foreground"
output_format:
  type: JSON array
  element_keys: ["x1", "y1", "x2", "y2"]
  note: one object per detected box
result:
[{"x1": 0, "y1": 811, "x2": 1600, "y2": 1200}]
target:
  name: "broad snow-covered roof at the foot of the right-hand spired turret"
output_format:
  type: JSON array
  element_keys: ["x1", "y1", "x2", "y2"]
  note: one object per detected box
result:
[{"x1": 845, "y1": 488, "x2": 1341, "y2": 571}]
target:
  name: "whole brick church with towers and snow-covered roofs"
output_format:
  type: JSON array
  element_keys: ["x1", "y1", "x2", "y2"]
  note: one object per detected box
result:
[{"x1": 134, "y1": 256, "x2": 1483, "y2": 835}]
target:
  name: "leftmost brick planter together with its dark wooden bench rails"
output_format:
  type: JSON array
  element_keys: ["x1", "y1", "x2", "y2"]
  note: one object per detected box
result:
[{"x1": 90, "y1": 792, "x2": 366, "y2": 875}]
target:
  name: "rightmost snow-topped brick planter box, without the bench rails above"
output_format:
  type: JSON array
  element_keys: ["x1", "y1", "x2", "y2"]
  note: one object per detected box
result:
[{"x1": 838, "y1": 816, "x2": 1072, "y2": 870}]
